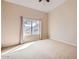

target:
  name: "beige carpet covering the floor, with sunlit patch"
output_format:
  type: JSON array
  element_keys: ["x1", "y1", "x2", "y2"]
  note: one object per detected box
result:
[{"x1": 1, "y1": 39, "x2": 77, "y2": 59}]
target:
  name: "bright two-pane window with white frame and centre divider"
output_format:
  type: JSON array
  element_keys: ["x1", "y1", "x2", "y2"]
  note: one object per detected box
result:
[{"x1": 23, "y1": 18, "x2": 41, "y2": 36}]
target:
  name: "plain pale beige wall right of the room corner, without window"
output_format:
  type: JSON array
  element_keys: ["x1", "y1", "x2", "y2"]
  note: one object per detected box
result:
[{"x1": 49, "y1": 0, "x2": 77, "y2": 46}]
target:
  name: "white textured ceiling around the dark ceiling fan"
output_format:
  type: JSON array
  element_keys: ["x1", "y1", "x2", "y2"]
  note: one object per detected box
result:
[{"x1": 5, "y1": 0, "x2": 66, "y2": 12}]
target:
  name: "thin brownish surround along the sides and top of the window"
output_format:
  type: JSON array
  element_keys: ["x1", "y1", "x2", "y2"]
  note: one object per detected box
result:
[{"x1": 19, "y1": 16, "x2": 43, "y2": 44}]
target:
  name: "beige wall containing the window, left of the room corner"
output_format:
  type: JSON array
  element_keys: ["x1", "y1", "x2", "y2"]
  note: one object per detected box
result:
[{"x1": 2, "y1": 2, "x2": 48, "y2": 47}]
